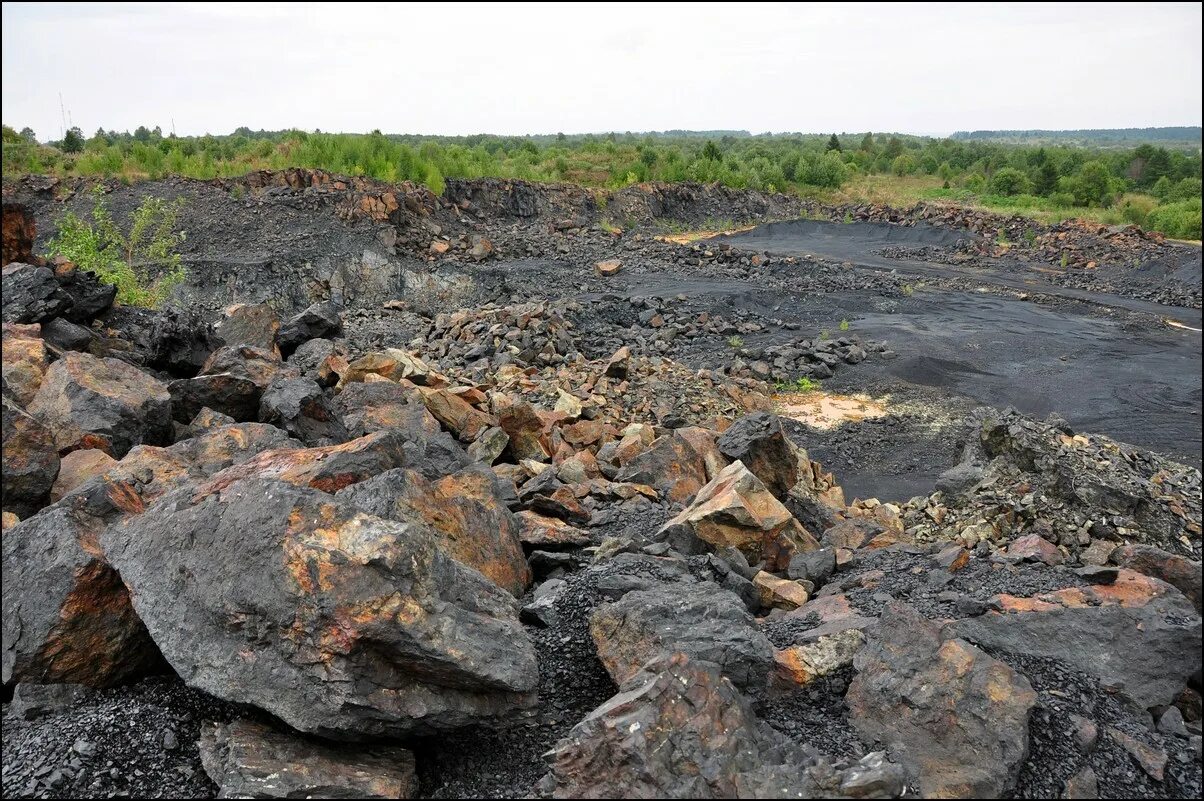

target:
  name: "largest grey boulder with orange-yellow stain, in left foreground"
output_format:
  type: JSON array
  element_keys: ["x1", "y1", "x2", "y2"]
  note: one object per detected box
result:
[{"x1": 104, "y1": 479, "x2": 537, "y2": 737}]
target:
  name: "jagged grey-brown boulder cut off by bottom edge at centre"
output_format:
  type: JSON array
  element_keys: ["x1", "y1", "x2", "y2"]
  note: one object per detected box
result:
[{"x1": 539, "y1": 654, "x2": 903, "y2": 799}]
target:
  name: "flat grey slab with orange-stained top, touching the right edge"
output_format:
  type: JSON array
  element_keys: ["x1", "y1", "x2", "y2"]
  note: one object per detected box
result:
[{"x1": 951, "y1": 570, "x2": 1202, "y2": 708}]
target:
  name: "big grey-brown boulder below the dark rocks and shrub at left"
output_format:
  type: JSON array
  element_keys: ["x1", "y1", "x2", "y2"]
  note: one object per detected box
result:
[{"x1": 29, "y1": 353, "x2": 171, "y2": 459}]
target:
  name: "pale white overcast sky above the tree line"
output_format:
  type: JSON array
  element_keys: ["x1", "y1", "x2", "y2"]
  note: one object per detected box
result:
[{"x1": 2, "y1": 2, "x2": 1202, "y2": 140}]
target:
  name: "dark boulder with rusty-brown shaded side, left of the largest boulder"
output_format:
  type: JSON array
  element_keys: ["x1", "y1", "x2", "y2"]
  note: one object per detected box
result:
[{"x1": 0, "y1": 494, "x2": 160, "y2": 687}]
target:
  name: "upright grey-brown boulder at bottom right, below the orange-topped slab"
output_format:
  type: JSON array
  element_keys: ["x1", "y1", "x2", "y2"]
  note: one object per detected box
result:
[{"x1": 845, "y1": 602, "x2": 1037, "y2": 799}]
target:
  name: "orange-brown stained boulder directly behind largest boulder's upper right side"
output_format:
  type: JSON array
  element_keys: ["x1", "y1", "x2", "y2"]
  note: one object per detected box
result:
[{"x1": 338, "y1": 469, "x2": 531, "y2": 595}]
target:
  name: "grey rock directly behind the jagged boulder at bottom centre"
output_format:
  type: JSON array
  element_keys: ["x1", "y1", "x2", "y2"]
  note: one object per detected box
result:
[{"x1": 590, "y1": 582, "x2": 773, "y2": 688}]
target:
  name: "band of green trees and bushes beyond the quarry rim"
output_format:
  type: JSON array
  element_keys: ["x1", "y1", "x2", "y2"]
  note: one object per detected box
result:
[{"x1": 4, "y1": 125, "x2": 1200, "y2": 240}]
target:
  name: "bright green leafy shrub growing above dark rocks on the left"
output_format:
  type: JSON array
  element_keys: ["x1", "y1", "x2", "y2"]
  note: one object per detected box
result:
[{"x1": 47, "y1": 185, "x2": 185, "y2": 308}]
